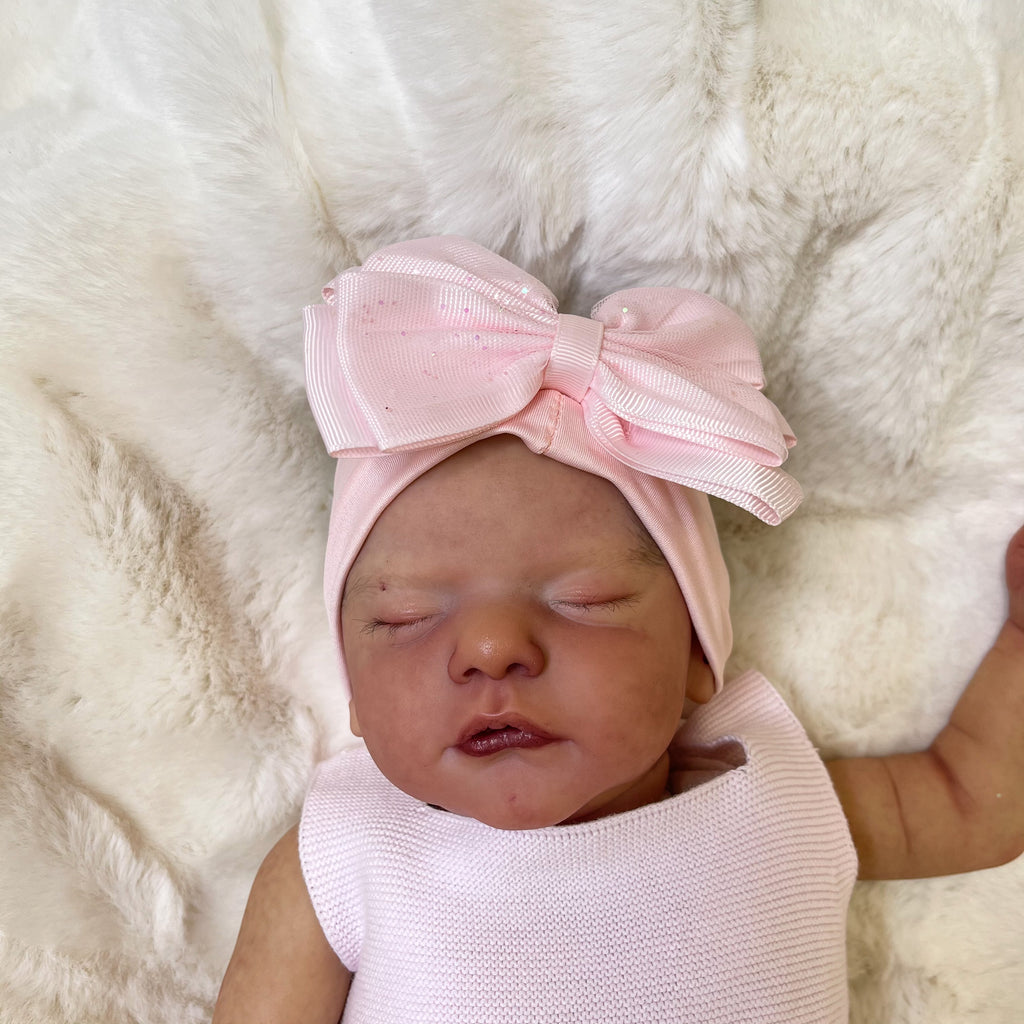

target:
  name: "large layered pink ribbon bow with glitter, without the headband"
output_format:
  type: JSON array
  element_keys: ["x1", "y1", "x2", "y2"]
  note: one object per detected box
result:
[{"x1": 305, "y1": 237, "x2": 802, "y2": 523}]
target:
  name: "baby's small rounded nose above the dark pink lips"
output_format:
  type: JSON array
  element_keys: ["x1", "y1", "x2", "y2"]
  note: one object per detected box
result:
[{"x1": 449, "y1": 604, "x2": 546, "y2": 683}]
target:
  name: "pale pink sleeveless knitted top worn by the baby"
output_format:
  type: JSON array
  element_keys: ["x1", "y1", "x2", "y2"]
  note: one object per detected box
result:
[{"x1": 299, "y1": 673, "x2": 856, "y2": 1024}]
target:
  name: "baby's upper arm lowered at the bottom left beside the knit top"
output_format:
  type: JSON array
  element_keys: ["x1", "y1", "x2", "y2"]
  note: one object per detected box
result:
[{"x1": 213, "y1": 826, "x2": 351, "y2": 1024}]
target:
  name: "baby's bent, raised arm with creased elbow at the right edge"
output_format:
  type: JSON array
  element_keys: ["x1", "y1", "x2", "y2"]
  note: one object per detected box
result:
[{"x1": 828, "y1": 527, "x2": 1024, "y2": 879}]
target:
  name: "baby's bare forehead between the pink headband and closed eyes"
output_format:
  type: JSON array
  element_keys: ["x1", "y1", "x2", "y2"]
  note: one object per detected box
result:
[{"x1": 342, "y1": 435, "x2": 666, "y2": 602}]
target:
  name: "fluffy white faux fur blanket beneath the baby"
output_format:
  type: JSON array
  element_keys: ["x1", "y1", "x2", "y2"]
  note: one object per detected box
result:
[{"x1": 0, "y1": 0, "x2": 1024, "y2": 1024}]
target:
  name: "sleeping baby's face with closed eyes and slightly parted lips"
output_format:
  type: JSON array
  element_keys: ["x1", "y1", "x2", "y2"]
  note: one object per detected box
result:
[{"x1": 341, "y1": 436, "x2": 713, "y2": 828}]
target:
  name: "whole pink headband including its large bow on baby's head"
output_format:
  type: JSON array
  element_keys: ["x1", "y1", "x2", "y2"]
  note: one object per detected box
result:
[{"x1": 305, "y1": 237, "x2": 802, "y2": 685}]
